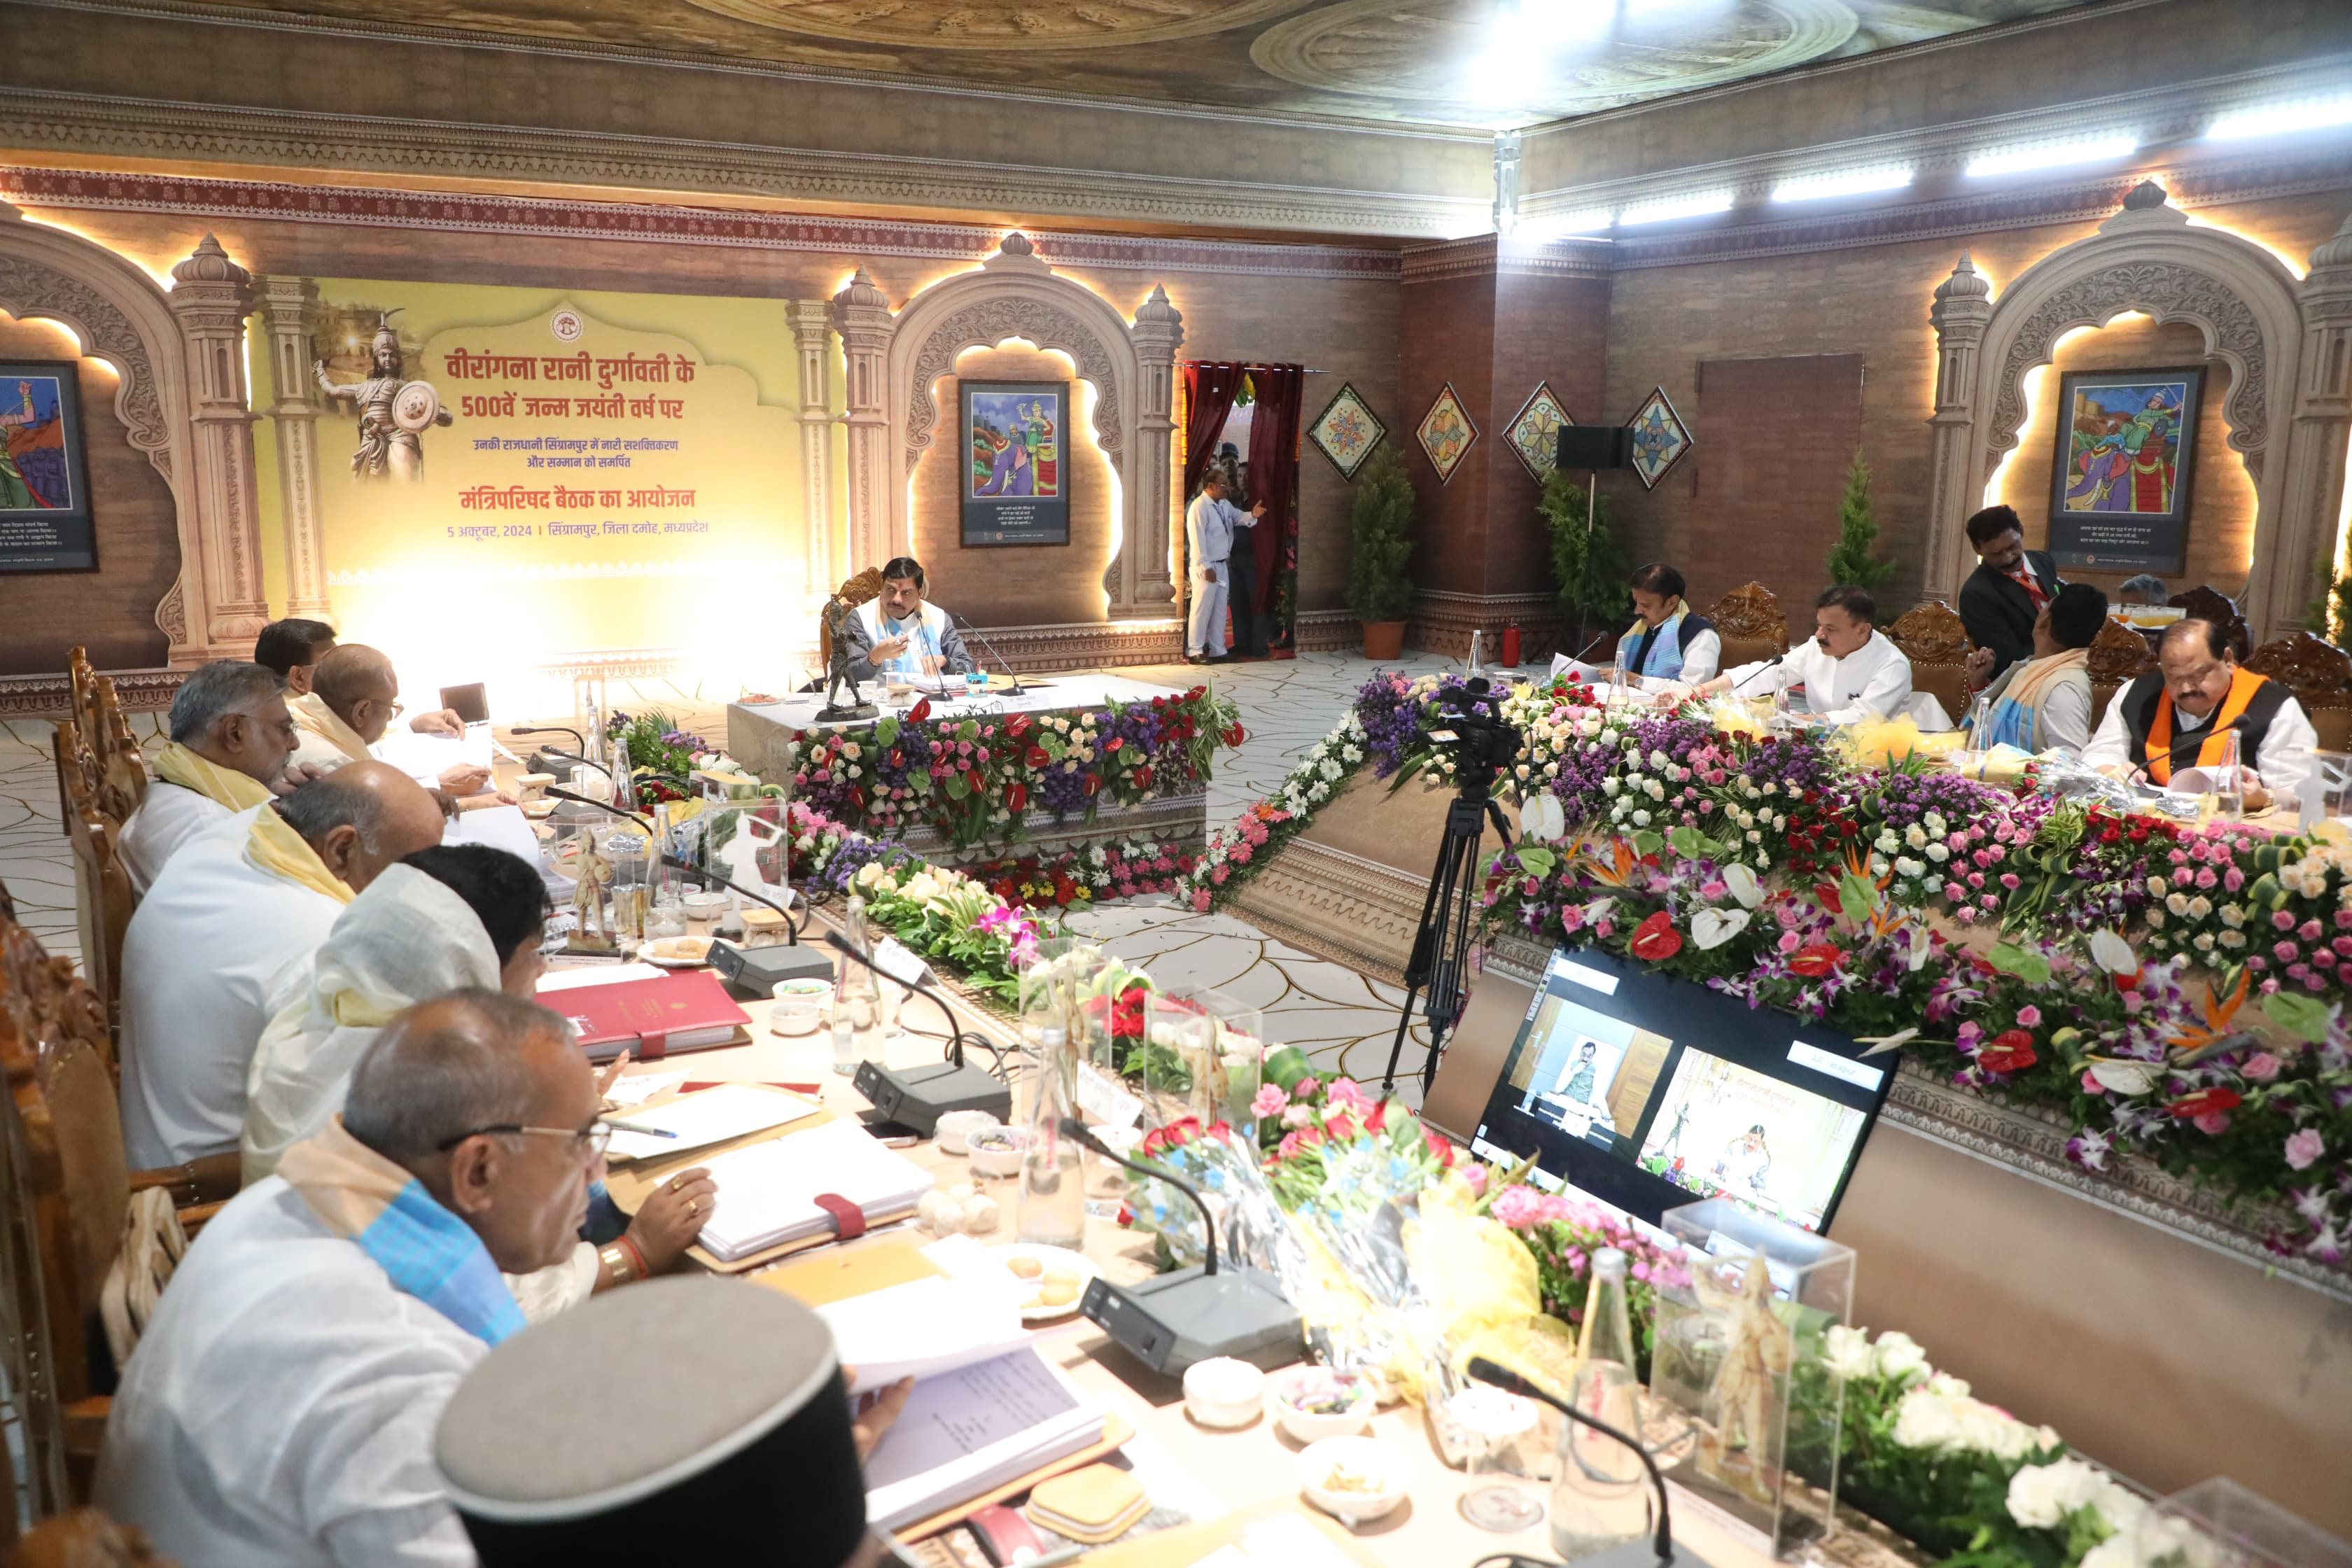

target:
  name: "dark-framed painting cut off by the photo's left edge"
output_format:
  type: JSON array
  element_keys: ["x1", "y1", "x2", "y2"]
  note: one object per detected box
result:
[{"x1": 0, "y1": 360, "x2": 99, "y2": 571}]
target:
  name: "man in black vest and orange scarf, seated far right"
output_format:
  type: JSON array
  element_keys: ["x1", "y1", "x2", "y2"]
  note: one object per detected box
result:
[{"x1": 2082, "y1": 618, "x2": 2319, "y2": 808}]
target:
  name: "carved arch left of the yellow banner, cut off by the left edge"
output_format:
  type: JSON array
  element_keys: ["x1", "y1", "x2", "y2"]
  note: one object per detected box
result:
[{"x1": 0, "y1": 202, "x2": 268, "y2": 665}]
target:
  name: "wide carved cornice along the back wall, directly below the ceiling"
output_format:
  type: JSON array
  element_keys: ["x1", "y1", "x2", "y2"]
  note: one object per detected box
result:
[{"x1": 0, "y1": 90, "x2": 1487, "y2": 237}]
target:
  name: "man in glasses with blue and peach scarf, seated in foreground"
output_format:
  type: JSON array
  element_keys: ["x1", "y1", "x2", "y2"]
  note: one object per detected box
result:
[{"x1": 97, "y1": 990, "x2": 626, "y2": 1568}]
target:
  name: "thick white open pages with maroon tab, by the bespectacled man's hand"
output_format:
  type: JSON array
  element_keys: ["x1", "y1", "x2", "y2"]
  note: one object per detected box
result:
[{"x1": 699, "y1": 1121, "x2": 934, "y2": 1262}]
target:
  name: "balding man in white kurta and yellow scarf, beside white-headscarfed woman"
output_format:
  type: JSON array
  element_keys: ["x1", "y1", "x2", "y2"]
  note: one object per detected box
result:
[{"x1": 122, "y1": 762, "x2": 442, "y2": 1170}]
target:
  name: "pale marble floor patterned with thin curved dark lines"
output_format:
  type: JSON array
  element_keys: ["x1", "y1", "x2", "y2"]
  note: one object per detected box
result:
[{"x1": 0, "y1": 654, "x2": 1453, "y2": 1091}]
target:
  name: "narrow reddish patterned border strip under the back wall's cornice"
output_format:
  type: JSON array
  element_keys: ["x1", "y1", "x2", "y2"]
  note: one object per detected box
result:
[{"x1": 0, "y1": 167, "x2": 1399, "y2": 280}]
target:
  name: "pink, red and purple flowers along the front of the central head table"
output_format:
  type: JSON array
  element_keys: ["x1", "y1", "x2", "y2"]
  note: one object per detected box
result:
[{"x1": 792, "y1": 687, "x2": 1244, "y2": 846}]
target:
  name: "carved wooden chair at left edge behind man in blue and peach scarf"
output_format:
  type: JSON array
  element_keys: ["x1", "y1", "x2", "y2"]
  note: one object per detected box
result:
[{"x1": 0, "y1": 921, "x2": 237, "y2": 1504}]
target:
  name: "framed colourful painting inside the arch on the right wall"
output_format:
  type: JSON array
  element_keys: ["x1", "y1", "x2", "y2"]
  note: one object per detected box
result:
[{"x1": 2049, "y1": 365, "x2": 2204, "y2": 576}]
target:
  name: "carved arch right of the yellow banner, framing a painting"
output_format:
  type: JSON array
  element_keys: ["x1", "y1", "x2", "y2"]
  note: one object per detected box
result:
[{"x1": 832, "y1": 232, "x2": 1183, "y2": 618}]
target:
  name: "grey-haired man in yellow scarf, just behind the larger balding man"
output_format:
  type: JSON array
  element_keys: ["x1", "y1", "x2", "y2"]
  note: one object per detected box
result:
[{"x1": 120, "y1": 658, "x2": 294, "y2": 893}]
